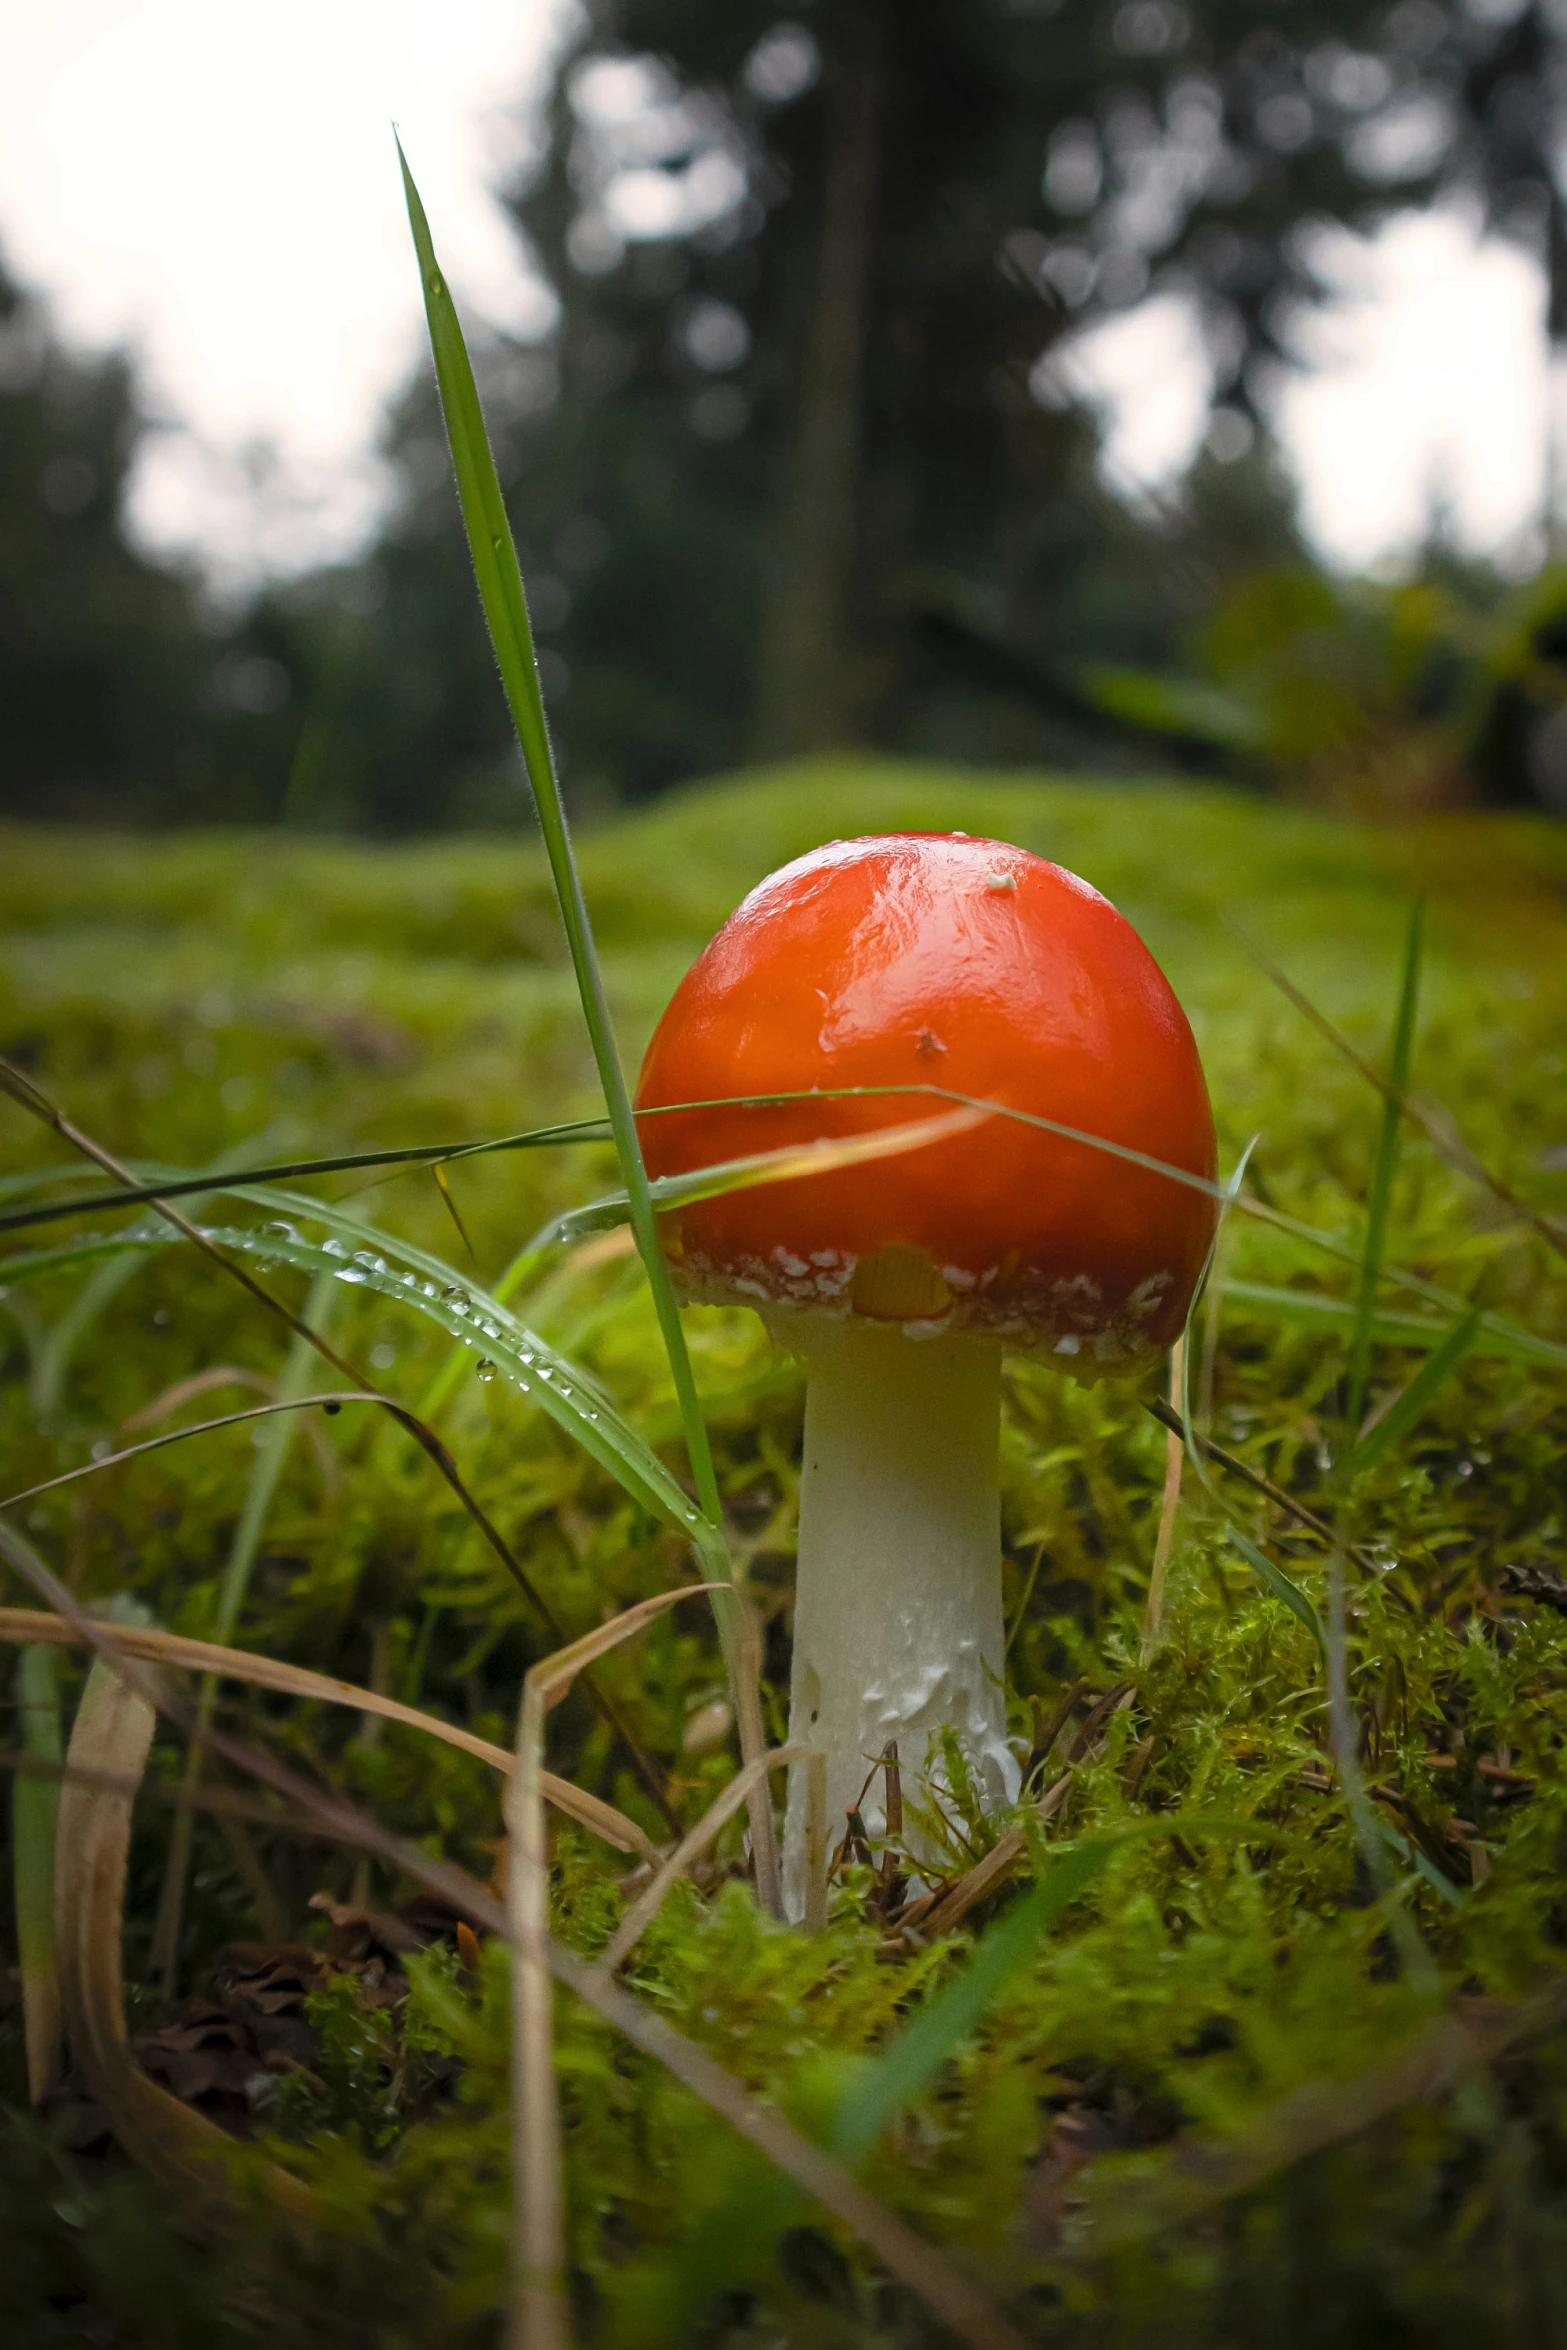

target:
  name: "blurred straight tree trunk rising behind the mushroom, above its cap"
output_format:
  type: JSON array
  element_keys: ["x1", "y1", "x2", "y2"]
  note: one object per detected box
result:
[{"x1": 754, "y1": 0, "x2": 883, "y2": 757}]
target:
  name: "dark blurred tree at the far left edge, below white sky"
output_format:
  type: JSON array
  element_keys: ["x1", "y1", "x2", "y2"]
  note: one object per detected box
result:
[{"x1": 0, "y1": 266, "x2": 239, "y2": 823}]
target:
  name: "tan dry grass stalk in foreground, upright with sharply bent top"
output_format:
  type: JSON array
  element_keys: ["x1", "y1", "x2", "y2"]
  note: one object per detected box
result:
[{"x1": 505, "y1": 1584, "x2": 717, "y2": 2350}]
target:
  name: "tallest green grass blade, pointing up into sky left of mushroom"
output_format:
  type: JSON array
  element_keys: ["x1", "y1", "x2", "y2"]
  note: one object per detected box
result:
[{"x1": 397, "y1": 146, "x2": 778, "y2": 1908}]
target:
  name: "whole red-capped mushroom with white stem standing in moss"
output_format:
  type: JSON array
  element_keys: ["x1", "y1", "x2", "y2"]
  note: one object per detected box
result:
[{"x1": 637, "y1": 832, "x2": 1215, "y2": 1915}]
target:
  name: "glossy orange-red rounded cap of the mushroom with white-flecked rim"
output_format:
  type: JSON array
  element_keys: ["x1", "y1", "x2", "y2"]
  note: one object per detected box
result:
[{"x1": 637, "y1": 832, "x2": 1215, "y2": 1375}]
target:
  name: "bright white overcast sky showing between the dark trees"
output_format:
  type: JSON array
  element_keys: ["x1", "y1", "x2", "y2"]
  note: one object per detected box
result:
[{"x1": 0, "y1": 0, "x2": 1548, "y2": 583}]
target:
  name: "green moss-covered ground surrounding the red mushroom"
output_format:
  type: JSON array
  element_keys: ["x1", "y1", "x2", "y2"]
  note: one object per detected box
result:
[{"x1": 0, "y1": 764, "x2": 1567, "y2": 2350}]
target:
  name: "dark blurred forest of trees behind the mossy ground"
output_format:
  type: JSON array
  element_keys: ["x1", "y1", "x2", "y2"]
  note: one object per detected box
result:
[{"x1": 0, "y1": 0, "x2": 1567, "y2": 832}]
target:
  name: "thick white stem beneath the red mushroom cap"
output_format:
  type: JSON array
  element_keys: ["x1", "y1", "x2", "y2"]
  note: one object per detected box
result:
[{"x1": 780, "y1": 1321, "x2": 1017, "y2": 1918}]
